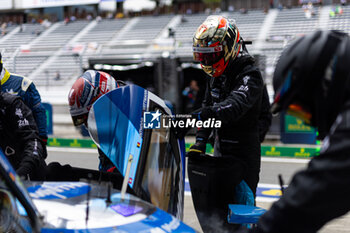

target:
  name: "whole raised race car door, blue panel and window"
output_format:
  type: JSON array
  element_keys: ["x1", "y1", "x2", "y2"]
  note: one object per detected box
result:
[{"x1": 88, "y1": 85, "x2": 185, "y2": 219}]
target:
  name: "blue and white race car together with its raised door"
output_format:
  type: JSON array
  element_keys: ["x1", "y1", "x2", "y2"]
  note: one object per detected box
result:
[{"x1": 0, "y1": 85, "x2": 195, "y2": 233}]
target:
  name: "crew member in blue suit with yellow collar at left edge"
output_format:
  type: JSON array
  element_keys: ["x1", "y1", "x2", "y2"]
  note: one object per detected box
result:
[{"x1": 0, "y1": 54, "x2": 47, "y2": 158}]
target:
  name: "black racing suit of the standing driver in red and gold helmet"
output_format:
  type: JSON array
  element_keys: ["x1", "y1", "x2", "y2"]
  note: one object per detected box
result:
[{"x1": 196, "y1": 54, "x2": 264, "y2": 194}]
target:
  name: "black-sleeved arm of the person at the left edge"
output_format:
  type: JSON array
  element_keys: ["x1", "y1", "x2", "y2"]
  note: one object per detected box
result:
[{"x1": 7, "y1": 98, "x2": 44, "y2": 176}]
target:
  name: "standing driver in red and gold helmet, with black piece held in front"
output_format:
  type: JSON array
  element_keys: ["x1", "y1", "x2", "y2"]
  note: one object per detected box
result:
[{"x1": 188, "y1": 16, "x2": 269, "y2": 232}]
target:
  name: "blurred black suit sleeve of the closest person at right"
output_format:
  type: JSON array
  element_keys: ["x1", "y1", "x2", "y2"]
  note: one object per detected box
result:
[{"x1": 239, "y1": 101, "x2": 350, "y2": 233}]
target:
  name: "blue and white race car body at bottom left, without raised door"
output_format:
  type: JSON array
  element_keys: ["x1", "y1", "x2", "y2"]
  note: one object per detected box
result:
[{"x1": 0, "y1": 150, "x2": 195, "y2": 233}]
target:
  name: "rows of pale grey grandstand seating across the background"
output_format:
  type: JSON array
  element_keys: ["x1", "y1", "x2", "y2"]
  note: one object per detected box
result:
[{"x1": 0, "y1": 6, "x2": 350, "y2": 91}]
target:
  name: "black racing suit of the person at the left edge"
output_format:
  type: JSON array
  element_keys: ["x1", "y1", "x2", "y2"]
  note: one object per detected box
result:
[{"x1": 0, "y1": 92, "x2": 46, "y2": 180}]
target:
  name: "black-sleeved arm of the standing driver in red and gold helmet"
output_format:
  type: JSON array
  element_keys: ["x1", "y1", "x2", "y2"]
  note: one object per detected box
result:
[{"x1": 200, "y1": 75, "x2": 263, "y2": 123}]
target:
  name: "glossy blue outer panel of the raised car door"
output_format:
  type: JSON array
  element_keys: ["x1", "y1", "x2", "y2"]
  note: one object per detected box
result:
[{"x1": 93, "y1": 85, "x2": 147, "y2": 187}]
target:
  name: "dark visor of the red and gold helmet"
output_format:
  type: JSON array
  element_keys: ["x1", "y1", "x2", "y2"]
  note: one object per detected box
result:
[{"x1": 193, "y1": 45, "x2": 224, "y2": 66}]
